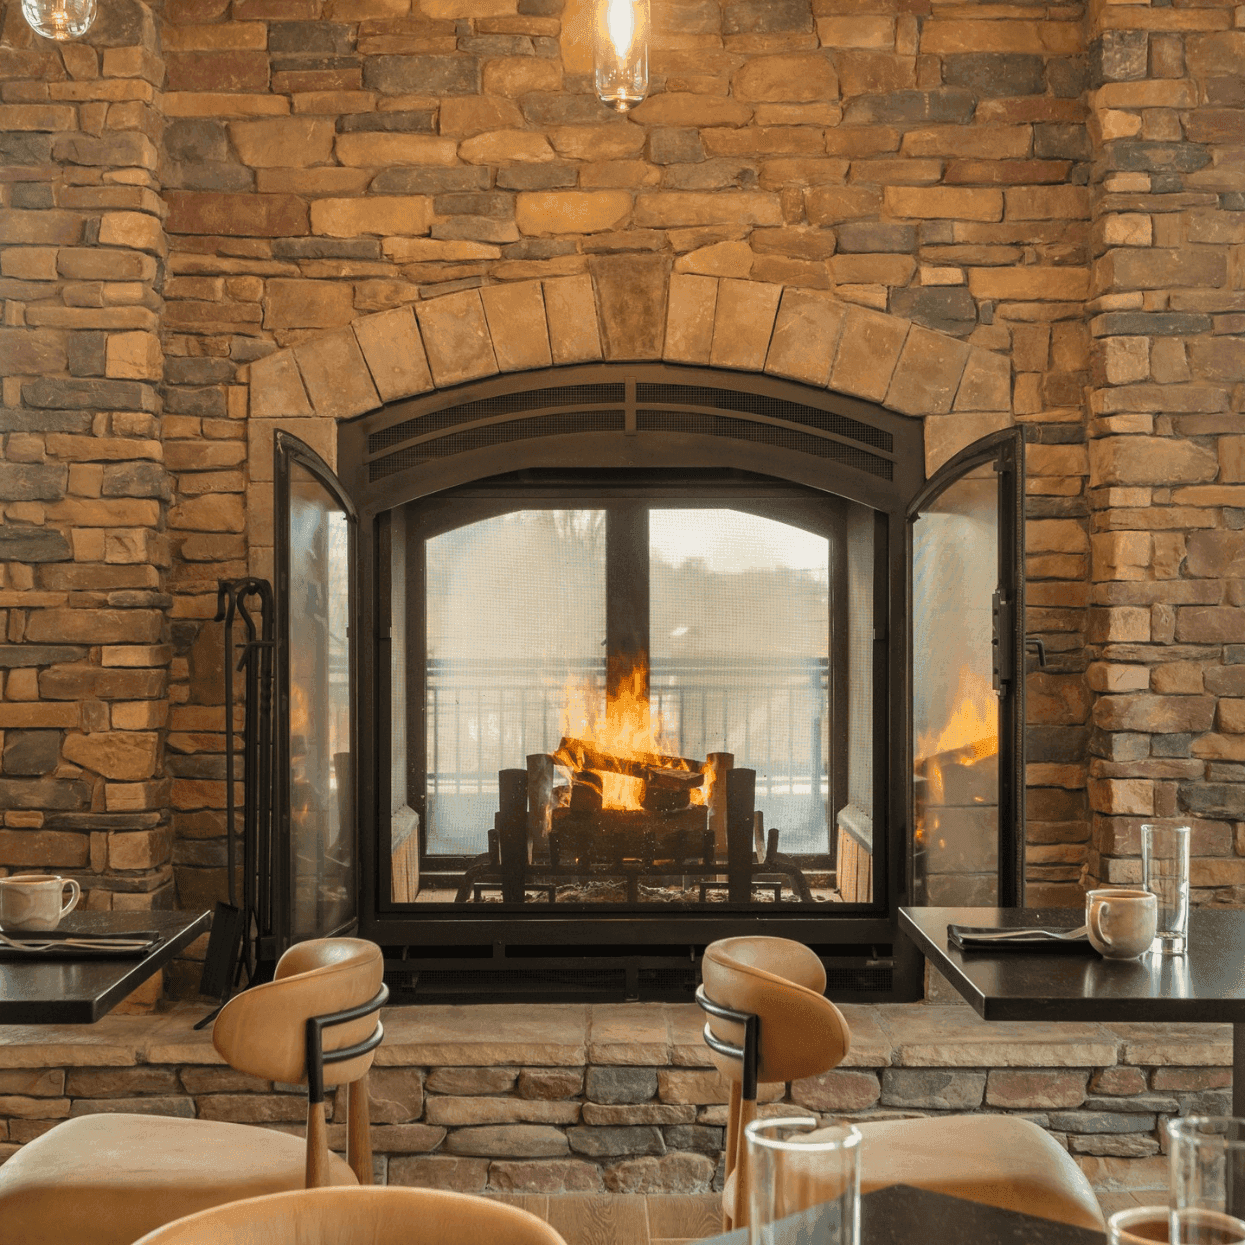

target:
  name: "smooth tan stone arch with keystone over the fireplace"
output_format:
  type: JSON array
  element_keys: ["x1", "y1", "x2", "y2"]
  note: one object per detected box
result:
[{"x1": 247, "y1": 272, "x2": 1013, "y2": 574}]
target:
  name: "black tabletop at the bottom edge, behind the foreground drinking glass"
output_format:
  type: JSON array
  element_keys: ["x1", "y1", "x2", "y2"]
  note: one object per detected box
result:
[{"x1": 701, "y1": 1184, "x2": 1107, "y2": 1245}]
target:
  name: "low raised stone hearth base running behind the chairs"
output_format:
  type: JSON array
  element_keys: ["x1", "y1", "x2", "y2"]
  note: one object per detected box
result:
[{"x1": 0, "y1": 1003, "x2": 1231, "y2": 1194}]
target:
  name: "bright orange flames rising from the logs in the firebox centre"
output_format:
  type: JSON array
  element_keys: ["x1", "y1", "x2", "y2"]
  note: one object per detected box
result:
[{"x1": 554, "y1": 665, "x2": 707, "y2": 809}]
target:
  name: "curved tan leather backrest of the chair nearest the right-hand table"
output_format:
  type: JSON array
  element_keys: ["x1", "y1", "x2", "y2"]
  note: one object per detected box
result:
[{"x1": 702, "y1": 937, "x2": 852, "y2": 1083}]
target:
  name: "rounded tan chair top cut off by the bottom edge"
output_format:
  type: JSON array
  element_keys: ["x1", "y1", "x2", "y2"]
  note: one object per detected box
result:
[{"x1": 134, "y1": 1186, "x2": 566, "y2": 1245}]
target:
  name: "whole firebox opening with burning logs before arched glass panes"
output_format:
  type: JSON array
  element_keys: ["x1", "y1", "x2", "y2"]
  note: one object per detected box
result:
[{"x1": 382, "y1": 489, "x2": 885, "y2": 911}]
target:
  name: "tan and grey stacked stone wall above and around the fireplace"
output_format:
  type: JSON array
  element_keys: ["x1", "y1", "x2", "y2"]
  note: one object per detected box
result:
[{"x1": 0, "y1": 0, "x2": 1245, "y2": 985}]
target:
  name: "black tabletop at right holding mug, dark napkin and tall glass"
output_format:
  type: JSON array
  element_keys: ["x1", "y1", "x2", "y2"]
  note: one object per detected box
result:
[{"x1": 899, "y1": 908, "x2": 1245, "y2": 1116}]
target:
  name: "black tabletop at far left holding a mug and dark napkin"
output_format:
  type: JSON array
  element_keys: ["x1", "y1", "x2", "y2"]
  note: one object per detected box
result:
[{"x1": 0, "y1": 913, "x2": 212, "y2": 1025}]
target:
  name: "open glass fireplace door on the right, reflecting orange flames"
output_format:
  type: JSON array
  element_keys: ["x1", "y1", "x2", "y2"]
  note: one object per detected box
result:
[{"x1": 910, "y1": 432, "x2": 1023, "y2": 908}]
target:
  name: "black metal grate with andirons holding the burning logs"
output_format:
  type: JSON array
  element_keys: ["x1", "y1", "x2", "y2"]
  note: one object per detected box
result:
[{"x1": 454, "y1": 738, "x2": 813, "y2": 904}]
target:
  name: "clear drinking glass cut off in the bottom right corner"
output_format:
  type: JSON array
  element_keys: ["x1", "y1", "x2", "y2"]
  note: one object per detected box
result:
[{"x1": 1167, "y1": 1116, "x2": 1245, "y2": 1245}]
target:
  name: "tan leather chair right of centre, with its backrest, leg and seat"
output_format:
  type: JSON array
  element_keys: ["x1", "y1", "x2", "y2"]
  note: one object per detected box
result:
[{"x1": 697, "y1": 937, "x2": 1103, "y2": 1231}]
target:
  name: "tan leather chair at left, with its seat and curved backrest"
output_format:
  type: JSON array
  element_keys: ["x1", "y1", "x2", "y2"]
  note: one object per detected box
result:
[{"x1": 0, "y1": 939, "x2": 385, "y2": 1245}]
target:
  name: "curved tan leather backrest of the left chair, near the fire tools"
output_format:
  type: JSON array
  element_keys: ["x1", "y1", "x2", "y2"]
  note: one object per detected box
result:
[{"x1": 212, "y1": 937, "x2": 385, "y2": 1086}]
